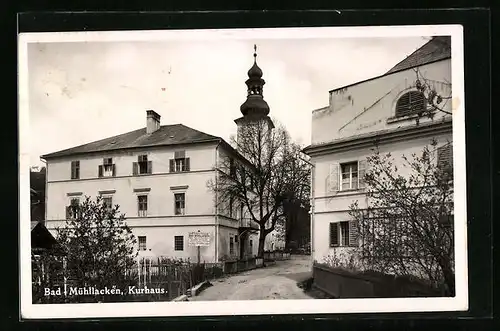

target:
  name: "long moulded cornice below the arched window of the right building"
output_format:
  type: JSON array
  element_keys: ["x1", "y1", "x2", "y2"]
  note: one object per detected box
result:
[{"x1": 303, "y1": 118, "x2": 452, "y2": 157}]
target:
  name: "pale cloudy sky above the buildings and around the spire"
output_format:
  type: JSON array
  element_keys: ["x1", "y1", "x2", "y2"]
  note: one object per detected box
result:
[{"x1": 28, "y1": 32, "x2": 429, "y2": 166}]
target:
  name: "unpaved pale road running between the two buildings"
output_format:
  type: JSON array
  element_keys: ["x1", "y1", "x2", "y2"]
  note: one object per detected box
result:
[{"x1": 189, "y1": 256, "x2": 311, "y2": 301}]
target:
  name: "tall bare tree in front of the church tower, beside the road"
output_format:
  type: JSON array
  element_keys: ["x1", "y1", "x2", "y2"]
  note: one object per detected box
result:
[{"x1": 209, "y1": 120, "x2": 310, "y2": 256}]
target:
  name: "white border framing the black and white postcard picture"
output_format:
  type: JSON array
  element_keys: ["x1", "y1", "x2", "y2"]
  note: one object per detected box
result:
[{"x1": 18, "y1": 25, "x2": 468, "y2": 319}]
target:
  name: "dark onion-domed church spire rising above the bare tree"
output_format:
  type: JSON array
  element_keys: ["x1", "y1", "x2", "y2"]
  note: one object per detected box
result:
[{"x1": 234, "y1": 45, "x2": 274, "y2": 150}]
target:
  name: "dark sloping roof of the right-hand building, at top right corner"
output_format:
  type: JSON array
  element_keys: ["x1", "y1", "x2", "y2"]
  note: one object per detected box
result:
[{"x1": 386, "y1": 36, "x2": 451, "y2": 74}]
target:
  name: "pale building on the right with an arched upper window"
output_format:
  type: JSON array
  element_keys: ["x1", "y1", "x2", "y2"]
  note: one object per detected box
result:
[{"x1": 304, "y1": 37, "x2": 453, "y2": 262}]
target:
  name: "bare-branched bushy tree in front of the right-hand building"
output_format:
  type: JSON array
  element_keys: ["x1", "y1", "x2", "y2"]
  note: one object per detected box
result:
[{"x1": 350, "y1": 139, "x2": 455, "y2": 295}]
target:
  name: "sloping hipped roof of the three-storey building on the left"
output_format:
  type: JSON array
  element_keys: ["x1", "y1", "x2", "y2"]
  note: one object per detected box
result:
[{"x1": 42, "y1": 124, "x2": 222, "y2": 159}]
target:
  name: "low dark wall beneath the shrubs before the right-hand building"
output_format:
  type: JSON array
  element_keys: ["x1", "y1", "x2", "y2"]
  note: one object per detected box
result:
[{"x1": 313, "y1": 264, "x2": 440, "y2": 298}]
